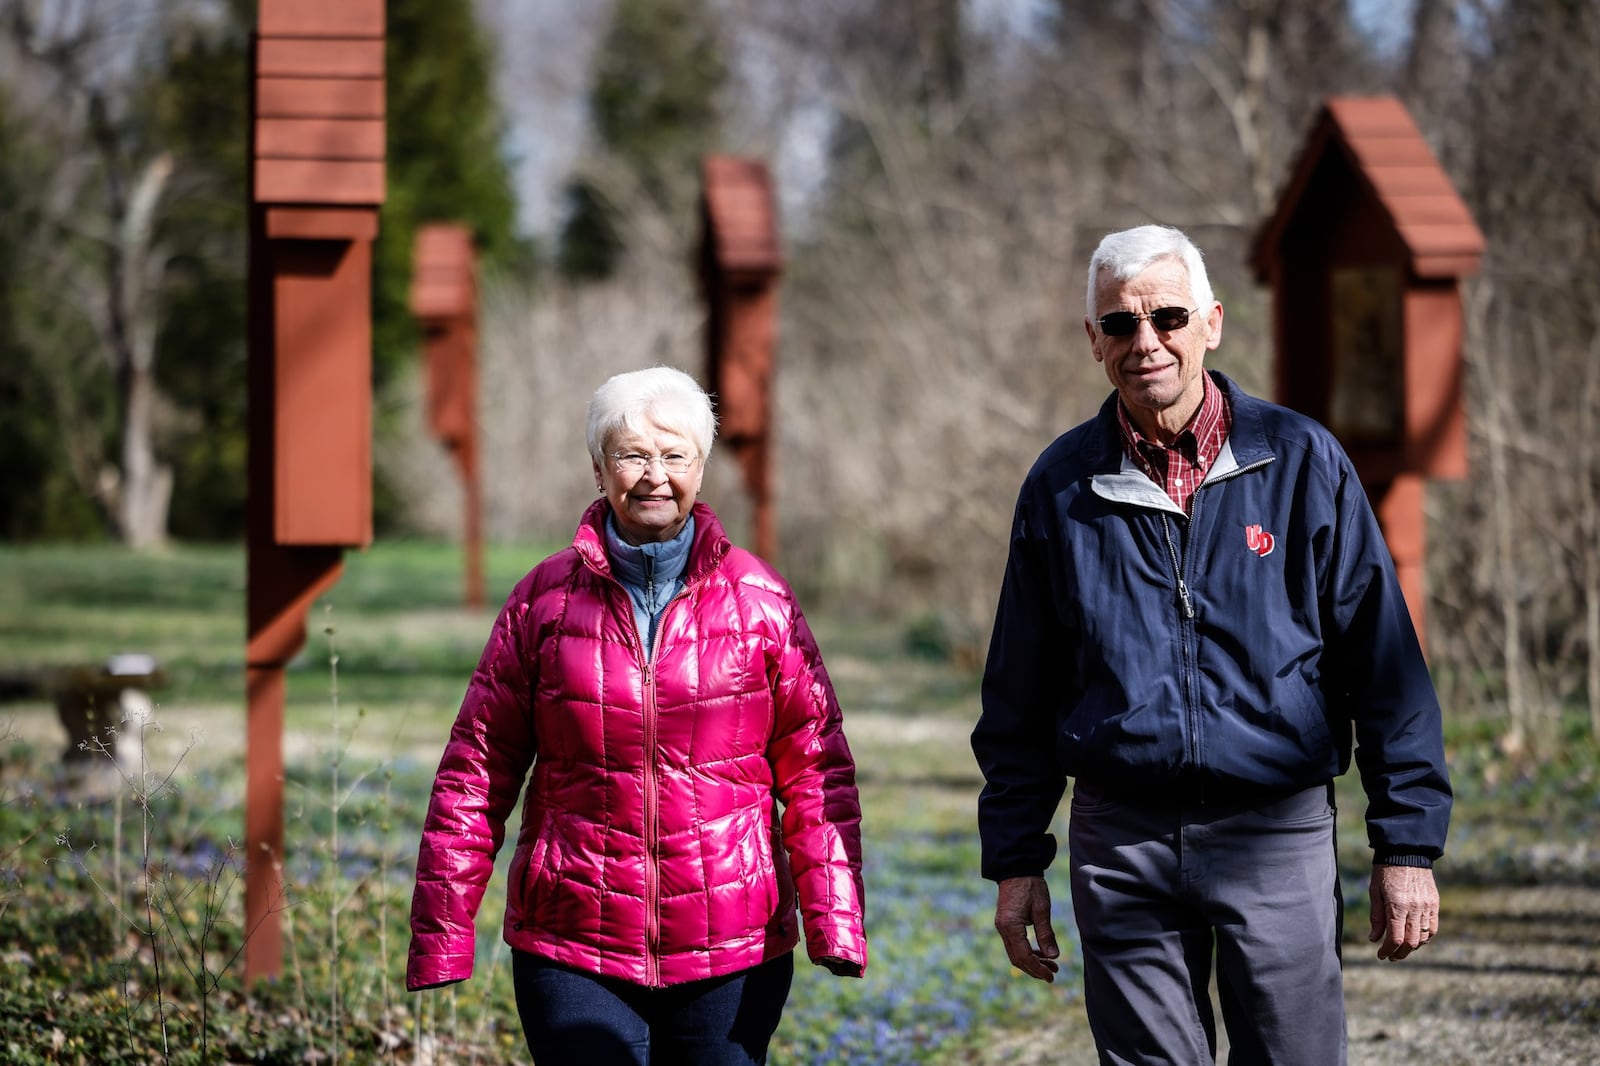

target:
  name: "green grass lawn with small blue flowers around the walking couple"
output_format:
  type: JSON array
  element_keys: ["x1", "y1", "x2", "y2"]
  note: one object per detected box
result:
[{"x1": 0, "y1": 543, "x2": 1600, "y2": 1064}]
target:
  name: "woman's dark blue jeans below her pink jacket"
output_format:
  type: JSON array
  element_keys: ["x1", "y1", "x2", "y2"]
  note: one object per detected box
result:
[{"x1": 512, "y1": 951, "x2": 795, "y2": 1066}]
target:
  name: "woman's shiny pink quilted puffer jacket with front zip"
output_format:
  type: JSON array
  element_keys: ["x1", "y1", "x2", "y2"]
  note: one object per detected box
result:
[{"x1": 406, "y1": 501, "x2": 867, "y2": 991}]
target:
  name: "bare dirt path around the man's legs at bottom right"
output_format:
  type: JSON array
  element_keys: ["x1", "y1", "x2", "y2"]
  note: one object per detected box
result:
[{"x1": 979, "y1": 887, "x2": 1600, "y2": 1066}]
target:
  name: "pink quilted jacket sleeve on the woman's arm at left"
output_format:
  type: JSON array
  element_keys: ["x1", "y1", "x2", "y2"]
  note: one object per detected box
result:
[{"x1": 406, "y1": 575, "x2": 534, "y2": 992}]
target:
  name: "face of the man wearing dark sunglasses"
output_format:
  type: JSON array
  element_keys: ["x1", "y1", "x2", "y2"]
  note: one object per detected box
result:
[{"x1": 1083, "y1": 259, "x2": 1222, "y2": 442}]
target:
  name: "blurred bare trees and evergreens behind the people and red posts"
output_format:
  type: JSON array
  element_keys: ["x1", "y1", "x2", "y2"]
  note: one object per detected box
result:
[{"x1": 0, "y1": 0, "x2": 1600, "y2": 754}]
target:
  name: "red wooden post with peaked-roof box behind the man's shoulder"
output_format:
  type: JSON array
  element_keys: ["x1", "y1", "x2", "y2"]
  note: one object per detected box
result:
[{"x1": 1253, "y1": 96, "x2": 1483, "y2": 647}]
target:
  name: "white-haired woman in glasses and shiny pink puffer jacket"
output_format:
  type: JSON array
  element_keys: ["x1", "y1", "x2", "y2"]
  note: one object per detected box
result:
[{"x1": 406, "y1": 367, "x2": 867, "y2": 1066}]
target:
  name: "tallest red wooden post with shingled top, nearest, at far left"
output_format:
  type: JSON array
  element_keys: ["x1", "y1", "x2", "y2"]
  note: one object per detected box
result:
[{"x1": 245, "y1": 0, "x2": 384, "y2": 981}]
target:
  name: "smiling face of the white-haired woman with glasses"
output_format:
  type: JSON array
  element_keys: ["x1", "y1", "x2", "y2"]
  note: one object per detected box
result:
[{"x1": 595, "y1": 421, "x2": 706, "y2": 544}]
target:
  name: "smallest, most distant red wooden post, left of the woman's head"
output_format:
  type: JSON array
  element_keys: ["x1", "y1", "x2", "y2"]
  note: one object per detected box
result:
[{"x1": 411, "y1": 222, "x2": 483, "y2": 607}]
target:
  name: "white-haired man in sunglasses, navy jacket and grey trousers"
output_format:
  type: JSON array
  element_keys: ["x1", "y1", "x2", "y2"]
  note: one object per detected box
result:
[{"x1": 973, "y1": 226, "x2": 1451, "y2": 1066}]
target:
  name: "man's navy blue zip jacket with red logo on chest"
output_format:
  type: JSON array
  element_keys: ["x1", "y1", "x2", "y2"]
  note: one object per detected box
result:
[{"x1": 973, "y1": 373, "x2": 1451, "y2": 880}]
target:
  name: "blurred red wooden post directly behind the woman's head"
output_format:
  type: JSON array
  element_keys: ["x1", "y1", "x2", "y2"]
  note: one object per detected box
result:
[{"x1": 701, "y1": 155, "x2": 782, "y2": 560}]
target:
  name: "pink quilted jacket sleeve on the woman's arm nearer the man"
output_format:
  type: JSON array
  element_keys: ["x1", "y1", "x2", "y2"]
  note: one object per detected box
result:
[{"x1": 766, "y1": 600, "x2": 867, "y2": 972}]
